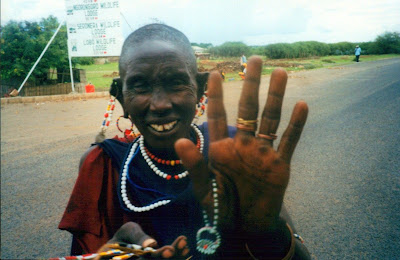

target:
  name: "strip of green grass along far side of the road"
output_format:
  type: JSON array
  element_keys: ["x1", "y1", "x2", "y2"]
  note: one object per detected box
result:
[{"x1": 78, "y1": 54, "x2": 400, "y2": 91}]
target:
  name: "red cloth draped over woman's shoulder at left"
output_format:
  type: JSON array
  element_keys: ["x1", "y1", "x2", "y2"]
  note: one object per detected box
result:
[{"x1": 58, "y1": 139, "x2": 150, "y2": 253}]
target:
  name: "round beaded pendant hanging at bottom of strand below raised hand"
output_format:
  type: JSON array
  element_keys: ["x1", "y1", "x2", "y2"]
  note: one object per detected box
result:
[{"x1": 196, "y1": 226, "x2": 221, "y2": 255}]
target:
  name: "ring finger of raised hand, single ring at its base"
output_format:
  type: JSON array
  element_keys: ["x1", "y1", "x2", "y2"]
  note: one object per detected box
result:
[{"x1": 259, "y1": 68, "x2": 287, "y2": 145}]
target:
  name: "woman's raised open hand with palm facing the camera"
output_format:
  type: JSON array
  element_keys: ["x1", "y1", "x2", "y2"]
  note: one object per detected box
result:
[{"x1": 175, "y1": 57, "x2": 308, "y2": 237}]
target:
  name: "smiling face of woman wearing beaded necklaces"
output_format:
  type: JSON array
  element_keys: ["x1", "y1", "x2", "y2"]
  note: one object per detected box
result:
[{"x1": 122, "y1": 40, "x2": 198, "y2": 150}]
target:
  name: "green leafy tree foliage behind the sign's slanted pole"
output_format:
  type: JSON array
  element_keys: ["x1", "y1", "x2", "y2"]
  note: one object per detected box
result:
[{"x1": 0, "y1": 16, "x2": 93, "y2": 83}]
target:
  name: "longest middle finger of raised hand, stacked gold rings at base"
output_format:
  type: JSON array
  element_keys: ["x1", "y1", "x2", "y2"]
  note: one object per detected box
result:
[{"x1": 237, "y1": 57, "x2": 262, "y2": 135}]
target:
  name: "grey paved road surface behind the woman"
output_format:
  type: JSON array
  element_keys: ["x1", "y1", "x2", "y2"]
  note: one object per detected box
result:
[{"x1": 1, "y1": 58, "x2": 400, "y2": 259}]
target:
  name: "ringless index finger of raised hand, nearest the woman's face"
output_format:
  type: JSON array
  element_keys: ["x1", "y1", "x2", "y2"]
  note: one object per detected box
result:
[{"x1": 207, "y1": 72, "x2": 228, "y2": 142}]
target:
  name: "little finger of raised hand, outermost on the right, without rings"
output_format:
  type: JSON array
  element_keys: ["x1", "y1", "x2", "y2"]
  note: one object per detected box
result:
[{"x1": 278, "y1": 101, "x2": 308, "y2": 163}]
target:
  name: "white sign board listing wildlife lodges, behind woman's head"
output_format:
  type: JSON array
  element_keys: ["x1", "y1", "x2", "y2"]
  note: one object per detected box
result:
[{"x1": 65, "y1": 0, "x2": 123, "y2": 57}]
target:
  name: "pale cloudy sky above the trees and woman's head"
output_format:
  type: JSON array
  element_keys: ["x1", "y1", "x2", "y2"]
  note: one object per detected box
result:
[{"x1": 1, "y1": 0, "x2": 400, "y2": 46}]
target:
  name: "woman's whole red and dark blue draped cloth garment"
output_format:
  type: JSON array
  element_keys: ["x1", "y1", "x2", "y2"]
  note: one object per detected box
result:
[{"x1": 58, "y1": 123, "x2": 236, "y2": 259}]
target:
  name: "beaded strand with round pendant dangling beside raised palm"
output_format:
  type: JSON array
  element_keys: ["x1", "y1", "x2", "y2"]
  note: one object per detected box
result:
[{"x1": 196, "y1": 179, "x2": 221, "y2": 255}]
